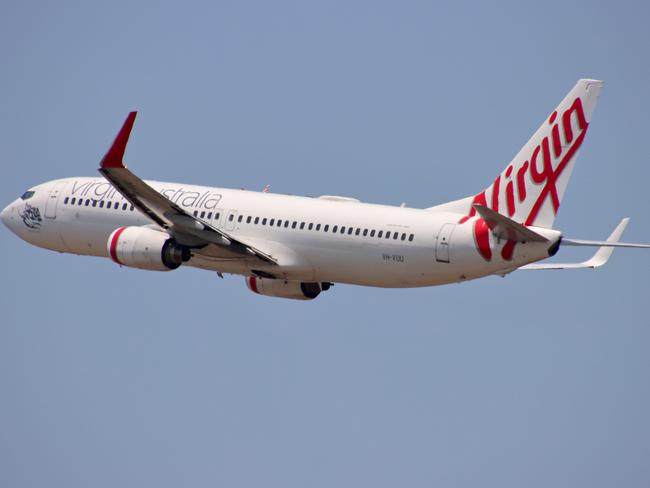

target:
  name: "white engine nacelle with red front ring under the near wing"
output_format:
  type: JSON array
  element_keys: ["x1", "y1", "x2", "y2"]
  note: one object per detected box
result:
[{"x1": 107, "y1": 226, "x2": 191, "y2": 271}]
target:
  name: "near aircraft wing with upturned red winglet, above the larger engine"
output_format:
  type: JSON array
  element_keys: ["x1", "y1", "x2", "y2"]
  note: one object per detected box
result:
[{"x1": 99, "y1": 112, "x2": 277, "y2": 264}]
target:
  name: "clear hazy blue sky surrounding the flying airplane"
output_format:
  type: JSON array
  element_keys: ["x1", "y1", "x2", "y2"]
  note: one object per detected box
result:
[{"x1": 0, "y1": 1, "x2": 650, "y2": 488}]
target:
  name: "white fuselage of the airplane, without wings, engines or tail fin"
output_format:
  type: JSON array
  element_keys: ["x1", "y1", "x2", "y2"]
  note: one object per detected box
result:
[{"x1": 2, "y1": 177, "x2": 559, "y2": 287}]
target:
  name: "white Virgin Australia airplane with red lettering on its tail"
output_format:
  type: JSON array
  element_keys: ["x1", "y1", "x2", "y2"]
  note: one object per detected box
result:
[{"x1": 0, "y1": 79, "x2": 650, "y2": 300}]
